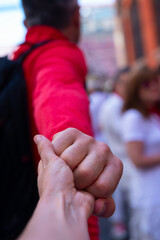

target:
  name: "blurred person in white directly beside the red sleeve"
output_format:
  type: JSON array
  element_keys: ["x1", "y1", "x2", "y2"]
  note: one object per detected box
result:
[{"x1": 87, "y1": 79, "x2": 109, "y2": 142}]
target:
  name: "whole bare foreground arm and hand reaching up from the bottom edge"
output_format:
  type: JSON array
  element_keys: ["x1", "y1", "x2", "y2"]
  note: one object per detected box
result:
[{"x1": 18, "y1": 136, "x2": 94, "y2": 240}]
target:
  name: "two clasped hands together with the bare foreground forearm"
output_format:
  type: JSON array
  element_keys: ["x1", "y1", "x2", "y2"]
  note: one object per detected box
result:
[{"x1": 18, "y1": 129, "x2": 122, "y2": 240}]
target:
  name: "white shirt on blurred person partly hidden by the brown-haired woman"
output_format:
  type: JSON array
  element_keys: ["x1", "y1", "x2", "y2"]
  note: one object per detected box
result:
[{"x1": 99, "y1": 93, "x2": 132, "y2": 187}]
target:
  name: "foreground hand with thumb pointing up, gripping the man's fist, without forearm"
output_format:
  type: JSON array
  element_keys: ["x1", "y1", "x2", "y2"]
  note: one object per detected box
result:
[{"x1": 34, "y1": 135, "x2": 94, "y2": 219}]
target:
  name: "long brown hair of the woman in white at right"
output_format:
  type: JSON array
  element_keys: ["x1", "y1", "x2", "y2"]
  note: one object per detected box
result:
[{"x1": 123, "y1": 69, "x2": 157, "y2": 117}]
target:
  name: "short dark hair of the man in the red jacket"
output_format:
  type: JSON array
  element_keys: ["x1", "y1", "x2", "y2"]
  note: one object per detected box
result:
[{"x1": 22, "y1": 0, "x2": 77, "y2": 30}]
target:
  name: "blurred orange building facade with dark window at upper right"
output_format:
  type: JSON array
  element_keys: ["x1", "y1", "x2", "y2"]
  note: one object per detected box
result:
[{"x1": 116, "y1": 0, "x2": 160, "y2": 68}]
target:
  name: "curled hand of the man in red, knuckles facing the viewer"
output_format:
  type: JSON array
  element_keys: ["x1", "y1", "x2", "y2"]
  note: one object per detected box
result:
[{"x1": 52, "y1": 128, "x2": 123, "y2": 217}]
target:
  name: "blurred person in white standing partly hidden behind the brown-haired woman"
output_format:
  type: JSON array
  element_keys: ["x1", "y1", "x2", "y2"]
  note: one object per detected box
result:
[{"x1": 99, "y1": 67, "x2": 130, "y2": 239}]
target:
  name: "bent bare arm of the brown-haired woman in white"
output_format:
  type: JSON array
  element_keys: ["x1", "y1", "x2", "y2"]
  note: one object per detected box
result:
[{"x1": 126, "y1": 141, "x2": 160, "y2": 168}]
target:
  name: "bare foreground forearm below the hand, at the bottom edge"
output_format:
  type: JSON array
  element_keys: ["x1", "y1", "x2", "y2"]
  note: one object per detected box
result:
[{"x1": 18, "y1": 193, "x2": 89, "y2": 240}]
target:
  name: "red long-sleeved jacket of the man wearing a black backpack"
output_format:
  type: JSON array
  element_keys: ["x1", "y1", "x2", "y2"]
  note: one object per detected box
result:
[{"x1": 13, "y1": 26, "x2": 98, "y2": 240}]
